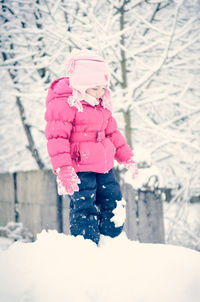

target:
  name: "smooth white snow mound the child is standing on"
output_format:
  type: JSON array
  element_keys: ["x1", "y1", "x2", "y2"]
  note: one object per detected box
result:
[{"x1": 0, "y1": 231, "x2": 200, "y2": 302}]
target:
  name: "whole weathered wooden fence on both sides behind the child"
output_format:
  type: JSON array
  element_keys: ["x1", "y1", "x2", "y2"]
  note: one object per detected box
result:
[{"x1": 0, "y1": 170, "x2": 164, "y2": 243}]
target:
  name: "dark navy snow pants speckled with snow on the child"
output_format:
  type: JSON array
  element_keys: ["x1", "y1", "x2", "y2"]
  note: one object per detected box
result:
[{"x1": 70, "y1": 169, "x2": 123, "y2": 243}]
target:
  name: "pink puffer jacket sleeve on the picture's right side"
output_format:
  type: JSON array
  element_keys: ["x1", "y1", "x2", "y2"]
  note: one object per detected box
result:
[{"x1": 105, "y1": 116, "x2": 133, "y2": 163}]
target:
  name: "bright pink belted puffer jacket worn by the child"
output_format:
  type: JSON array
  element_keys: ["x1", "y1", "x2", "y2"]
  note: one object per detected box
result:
[{"x1": 45, "y1": 78, "x2": 133, "y2": 173}]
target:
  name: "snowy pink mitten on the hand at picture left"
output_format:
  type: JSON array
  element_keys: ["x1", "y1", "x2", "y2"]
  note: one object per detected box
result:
[{"x1": 56, "y1": 166, "x2": 80, "y2": 195}]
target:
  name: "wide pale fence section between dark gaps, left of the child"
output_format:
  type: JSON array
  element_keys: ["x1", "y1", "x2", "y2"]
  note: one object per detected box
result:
[{"x1": 17, "y1": 170, "x2": 59, "y2": 236}]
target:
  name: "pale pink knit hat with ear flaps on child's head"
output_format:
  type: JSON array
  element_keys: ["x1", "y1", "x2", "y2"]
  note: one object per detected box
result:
[{"x1": 66, "y1": 50, "x2": 111, "y2": 111}]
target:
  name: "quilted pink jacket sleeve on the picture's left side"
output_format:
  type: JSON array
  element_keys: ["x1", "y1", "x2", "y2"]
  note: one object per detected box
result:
[{"x1": 45, "y1": 96, "x2": 75, "y2": 173}]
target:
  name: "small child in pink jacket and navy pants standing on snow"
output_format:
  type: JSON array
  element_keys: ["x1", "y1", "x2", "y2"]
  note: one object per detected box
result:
[{"x1": 45, "y1": 51, "x2": 137, "y2": 243}]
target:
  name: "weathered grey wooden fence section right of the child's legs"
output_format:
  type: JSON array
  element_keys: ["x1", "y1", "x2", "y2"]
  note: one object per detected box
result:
[{"x1": 121, "y1": 179, "x2": 165, "y2": 243}]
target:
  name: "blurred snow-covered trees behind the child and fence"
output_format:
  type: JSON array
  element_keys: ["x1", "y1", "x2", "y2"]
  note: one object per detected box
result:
[{"x1": 0, "y1": 0, "x2": 200, "y2": 250}]
